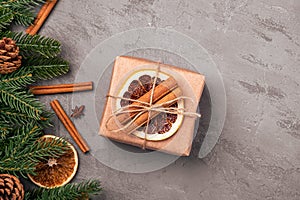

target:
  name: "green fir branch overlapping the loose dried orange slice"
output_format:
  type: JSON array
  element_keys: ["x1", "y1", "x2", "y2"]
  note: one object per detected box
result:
[{"x1": 0, "y1": 126, "x2": 68, "y2": 177}]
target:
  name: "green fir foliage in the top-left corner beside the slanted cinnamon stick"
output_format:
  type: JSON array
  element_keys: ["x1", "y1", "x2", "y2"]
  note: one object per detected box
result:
[{"x1": 0, "y1": 0, "x2": 44, "y2": 30}]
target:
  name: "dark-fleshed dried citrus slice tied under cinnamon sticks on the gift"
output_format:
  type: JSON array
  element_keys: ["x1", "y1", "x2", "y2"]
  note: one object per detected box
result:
[{"x1": 116, "y1": 69, "x2": 184, "y2": 141}]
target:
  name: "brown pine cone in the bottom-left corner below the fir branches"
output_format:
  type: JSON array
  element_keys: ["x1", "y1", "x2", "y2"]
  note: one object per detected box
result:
[{"x1": 0, "y1": 174, "x2": 24, "y2": 200}]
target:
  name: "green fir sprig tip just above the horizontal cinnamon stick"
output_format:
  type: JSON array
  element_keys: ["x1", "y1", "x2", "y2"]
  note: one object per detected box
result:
[{"x1": 24, "y1": 57, "x2": 69, "y2": 80}]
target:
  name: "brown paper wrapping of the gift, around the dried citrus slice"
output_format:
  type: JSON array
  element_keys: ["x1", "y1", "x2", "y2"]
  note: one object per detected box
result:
[{"x1": 99, "y1": 56, "x2": 205, "y2": 156}]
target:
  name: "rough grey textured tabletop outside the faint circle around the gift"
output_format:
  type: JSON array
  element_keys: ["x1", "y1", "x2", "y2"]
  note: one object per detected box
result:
[{"x1": 30, "y1": 0, "x2": 300, "y2": 200}]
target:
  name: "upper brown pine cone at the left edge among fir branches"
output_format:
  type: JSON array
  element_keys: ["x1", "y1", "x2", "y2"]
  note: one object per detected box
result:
[{"x1": 0, "y1": 37, "x2": 22, "y2": 74}]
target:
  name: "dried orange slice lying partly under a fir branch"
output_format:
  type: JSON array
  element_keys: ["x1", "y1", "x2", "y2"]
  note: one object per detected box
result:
[{"x1": 28, "y1": 135, "x2": 78, "y2": 189}]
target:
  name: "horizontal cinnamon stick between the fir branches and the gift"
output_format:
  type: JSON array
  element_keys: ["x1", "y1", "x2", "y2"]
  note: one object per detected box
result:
[{"x1": 29, "y1": 81, "x2": 93, "y2": 95}]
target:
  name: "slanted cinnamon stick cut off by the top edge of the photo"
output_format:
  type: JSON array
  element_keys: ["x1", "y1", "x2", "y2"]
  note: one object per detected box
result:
[{"x1": 26, "y1": 0, "x2": 57, "y2": 35}]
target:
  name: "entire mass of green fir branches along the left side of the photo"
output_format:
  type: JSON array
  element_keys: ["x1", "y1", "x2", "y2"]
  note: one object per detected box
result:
[{"x1": 0, "y1": 3, "x2": 102, "y2": 200}]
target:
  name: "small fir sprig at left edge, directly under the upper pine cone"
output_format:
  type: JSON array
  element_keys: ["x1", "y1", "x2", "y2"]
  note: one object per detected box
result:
[{"x1": 0, "y1": 66, "x2": 35, "y2": 87}]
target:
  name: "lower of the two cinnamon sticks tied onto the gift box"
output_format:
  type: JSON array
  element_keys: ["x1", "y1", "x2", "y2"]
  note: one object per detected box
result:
[{"x1": 108, "y1": 87, "x2": 182, "y2": 134}]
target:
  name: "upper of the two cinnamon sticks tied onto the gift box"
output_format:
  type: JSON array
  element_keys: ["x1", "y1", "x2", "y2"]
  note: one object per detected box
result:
[{"x1": 116, "y1": 77, "x2": 177, "y2": 124}]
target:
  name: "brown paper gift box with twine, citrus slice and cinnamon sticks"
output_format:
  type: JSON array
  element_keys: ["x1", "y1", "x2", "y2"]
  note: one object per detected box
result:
[{"x1": 99, "y1": 56, "x2": 205, "y2": 156}]
